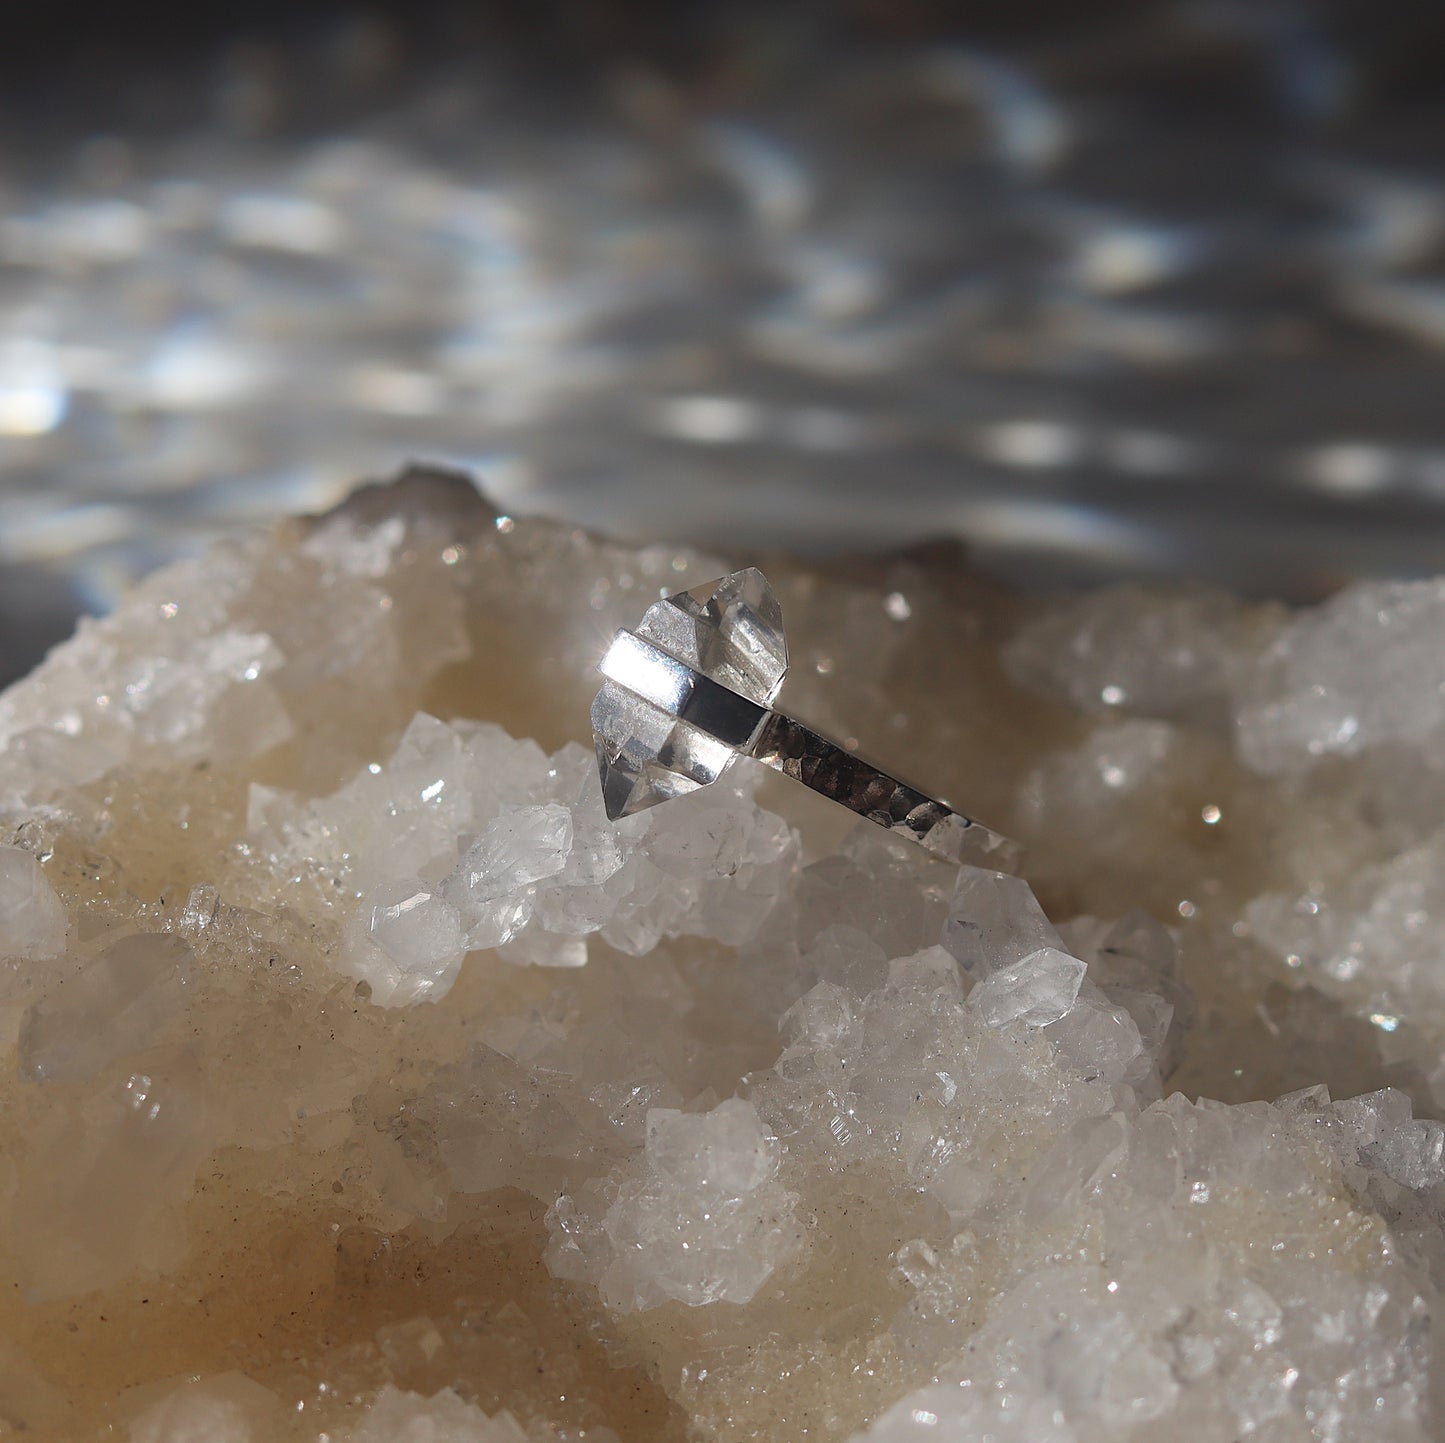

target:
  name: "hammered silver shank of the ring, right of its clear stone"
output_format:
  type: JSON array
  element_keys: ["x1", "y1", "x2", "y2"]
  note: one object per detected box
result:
[{"x1": 747, "y1": 712, "x2": 1022, "y2": 871}]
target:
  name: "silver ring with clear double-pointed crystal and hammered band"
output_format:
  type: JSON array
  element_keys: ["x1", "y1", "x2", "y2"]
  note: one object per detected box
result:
[{"x1": 592, "y1": 566, "x2": 1020, "y2": 871}]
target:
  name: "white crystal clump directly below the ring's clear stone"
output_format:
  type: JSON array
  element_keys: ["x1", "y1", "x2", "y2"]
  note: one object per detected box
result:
[{"x1": 258, "y1": 702, "x2": 796, "y2": 1005}]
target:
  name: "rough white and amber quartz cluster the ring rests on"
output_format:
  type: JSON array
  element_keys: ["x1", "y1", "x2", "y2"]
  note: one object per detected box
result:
[{"x1": 0, "y1": 474, "x2": 1445, "y2": 1443}]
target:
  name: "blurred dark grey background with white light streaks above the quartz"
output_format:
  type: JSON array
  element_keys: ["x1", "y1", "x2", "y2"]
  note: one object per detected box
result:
[{"x1": 0, "y1": 0, "x2": 1445, "y2": 679}]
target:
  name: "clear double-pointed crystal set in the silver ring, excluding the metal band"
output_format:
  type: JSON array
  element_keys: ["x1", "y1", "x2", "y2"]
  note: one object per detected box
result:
[{"x1": 592, "y1": 566, "x2": 788, "y2": 820}]
